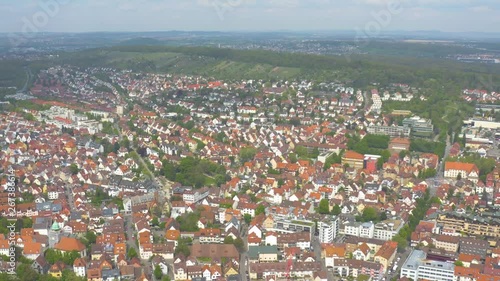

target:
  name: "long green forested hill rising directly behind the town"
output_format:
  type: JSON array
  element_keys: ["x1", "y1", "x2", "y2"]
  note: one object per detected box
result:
[{"x1": 58, "y1": 46, "x2": 500, "y2": 90}]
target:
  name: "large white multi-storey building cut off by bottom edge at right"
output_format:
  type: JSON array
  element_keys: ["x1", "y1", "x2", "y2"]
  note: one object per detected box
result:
[{"x1": 400, "y1": 250, "x2": 455, "y2": 281}]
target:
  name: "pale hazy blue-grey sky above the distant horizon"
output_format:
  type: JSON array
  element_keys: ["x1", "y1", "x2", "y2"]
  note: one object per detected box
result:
[{"x1": 0, "y1": 0, "x2": 500, "y2": 33}]
